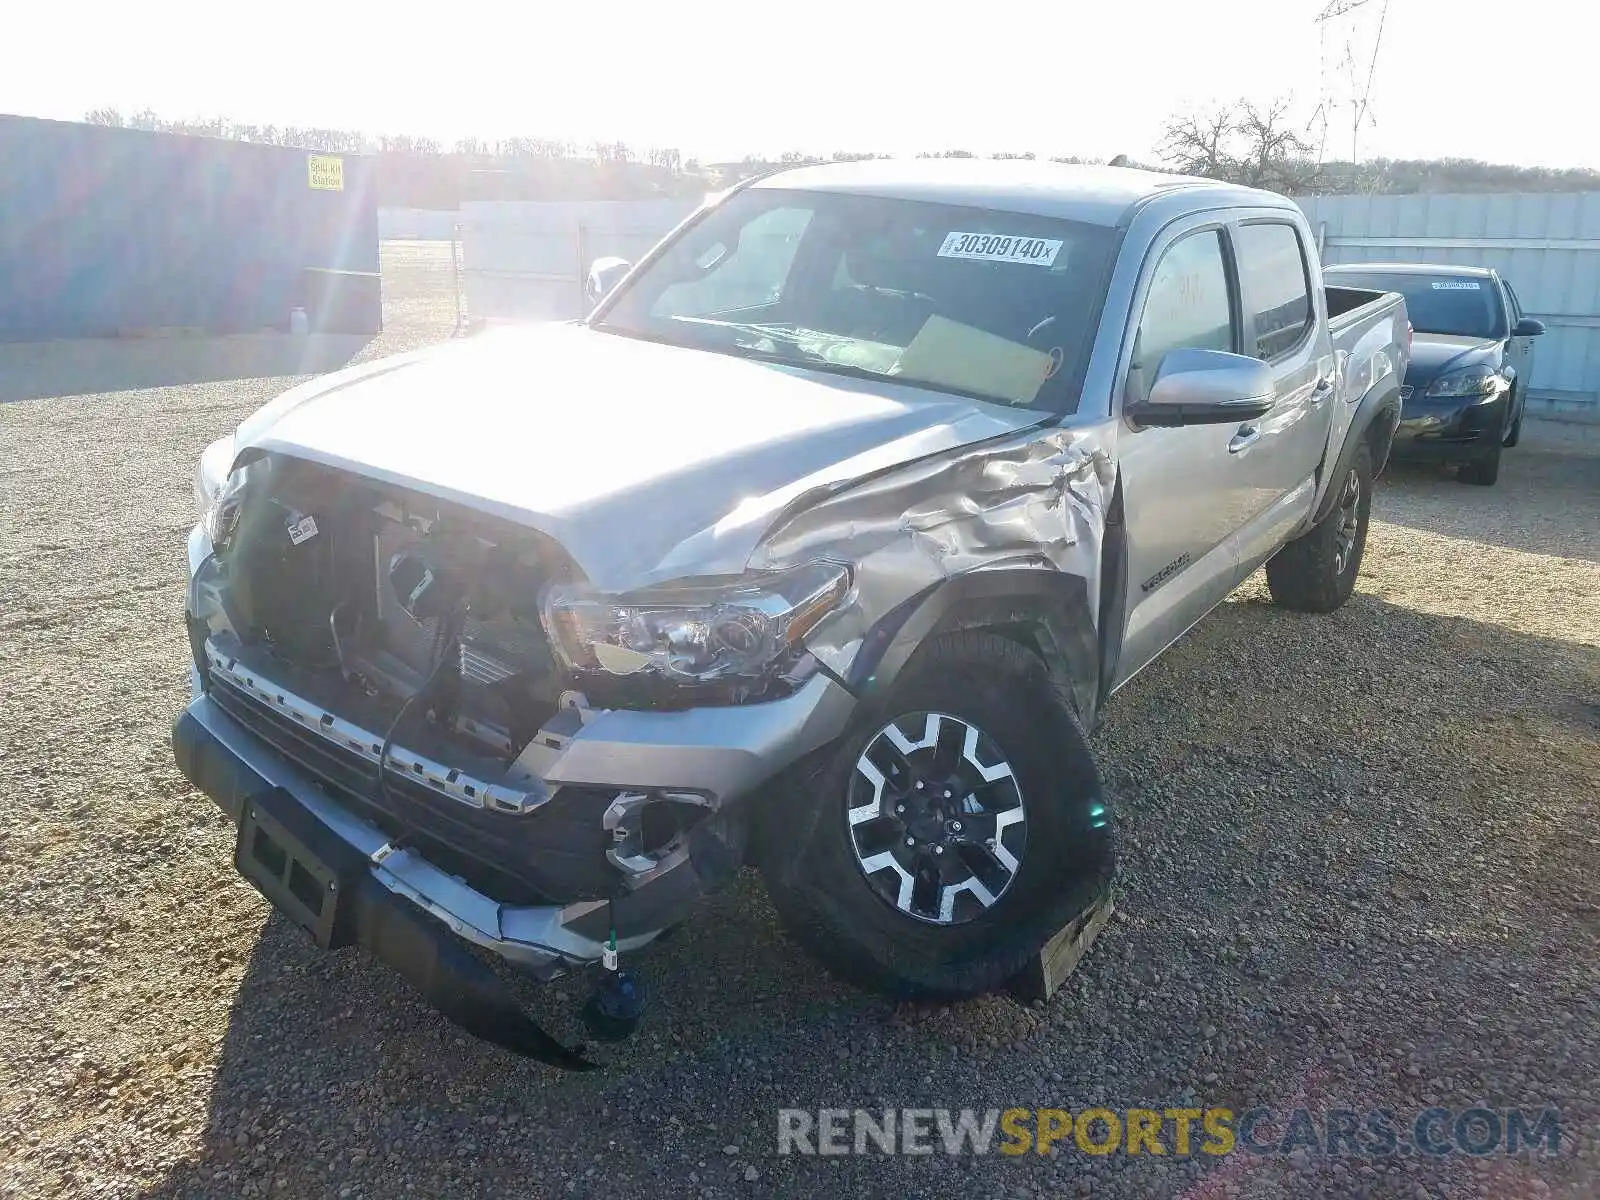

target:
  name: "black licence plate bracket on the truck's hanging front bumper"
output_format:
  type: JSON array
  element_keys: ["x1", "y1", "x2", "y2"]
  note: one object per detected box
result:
[{"x1": 234, "y1": 792, "x2": 354, "y2": 950}]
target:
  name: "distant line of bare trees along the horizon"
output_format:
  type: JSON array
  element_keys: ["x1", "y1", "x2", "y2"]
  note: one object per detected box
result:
[{"x1": 85, "y1": 109, "x2": 1600, "y2": 210}]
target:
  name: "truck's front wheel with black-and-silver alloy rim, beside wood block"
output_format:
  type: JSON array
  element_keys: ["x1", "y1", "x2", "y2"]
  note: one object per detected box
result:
[{"x1": 758, "y1": 632, "x2": 1114, "y2": 1000}]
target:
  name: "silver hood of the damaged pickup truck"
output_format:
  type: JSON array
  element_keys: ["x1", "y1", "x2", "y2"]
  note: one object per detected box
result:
[{"x1": 235, "y1": 325, "x2": 1042, "y2": 590}]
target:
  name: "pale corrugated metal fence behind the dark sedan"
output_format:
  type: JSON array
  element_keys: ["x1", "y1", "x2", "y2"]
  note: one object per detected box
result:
[{"x1": 1299, "y1": 192, "x2": 1600, "y2": 416}]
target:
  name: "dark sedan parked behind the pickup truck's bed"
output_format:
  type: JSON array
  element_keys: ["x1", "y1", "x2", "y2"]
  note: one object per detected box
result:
[{"x1": 1323, "y1": 262, "x2": 1544, "y2": 485}]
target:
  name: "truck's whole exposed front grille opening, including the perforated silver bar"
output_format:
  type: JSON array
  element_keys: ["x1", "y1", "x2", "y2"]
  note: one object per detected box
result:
[{"x1": 195, "y1": 454, "x2": 621, "y2": 904}]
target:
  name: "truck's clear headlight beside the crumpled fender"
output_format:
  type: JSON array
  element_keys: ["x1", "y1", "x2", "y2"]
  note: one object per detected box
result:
[{"x1": 542, "y1": 562, "x2": 850, "y2": 683}]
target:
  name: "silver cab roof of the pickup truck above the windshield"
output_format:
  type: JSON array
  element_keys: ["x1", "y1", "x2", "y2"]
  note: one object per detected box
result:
[{"x1": 750, "y1": 158, "x2": 1298, "y2": 226}]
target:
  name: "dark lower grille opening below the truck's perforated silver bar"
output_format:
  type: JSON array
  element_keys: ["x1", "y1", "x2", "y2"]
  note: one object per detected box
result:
[{"x1": 211, "y1": 662, "x2": 621, "y2": 904}]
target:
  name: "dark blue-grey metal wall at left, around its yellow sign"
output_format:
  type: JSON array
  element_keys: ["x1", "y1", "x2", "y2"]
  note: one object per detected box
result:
[{"x1": 0, "y1": 117, "x2": 381, "y2": 341}]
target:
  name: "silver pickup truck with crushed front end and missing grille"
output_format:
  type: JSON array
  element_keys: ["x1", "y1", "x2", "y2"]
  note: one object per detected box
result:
[{"x1": 173, "y1": 160, "x2": 1410, "y2": 1066}]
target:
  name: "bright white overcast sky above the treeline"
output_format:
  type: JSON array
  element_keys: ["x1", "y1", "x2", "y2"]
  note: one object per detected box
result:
[{"x1": 0, "y1": 0, "x2": 1600, "y2": 166}]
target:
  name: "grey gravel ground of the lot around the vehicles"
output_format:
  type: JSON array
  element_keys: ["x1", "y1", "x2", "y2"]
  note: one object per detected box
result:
[{"x1": 0, "y1": 246, "x2": 1600, "y2": 1197}]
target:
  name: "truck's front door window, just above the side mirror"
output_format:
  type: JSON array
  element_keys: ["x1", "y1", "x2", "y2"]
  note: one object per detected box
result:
[{"x1": 1134, "y1": 229, "x2": 1234, "y2": 387}]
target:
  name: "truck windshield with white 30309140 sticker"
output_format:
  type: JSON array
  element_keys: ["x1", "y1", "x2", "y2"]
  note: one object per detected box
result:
[{"x1": 592, "y1": 187, "x2": 1115, "y2": 413}]
